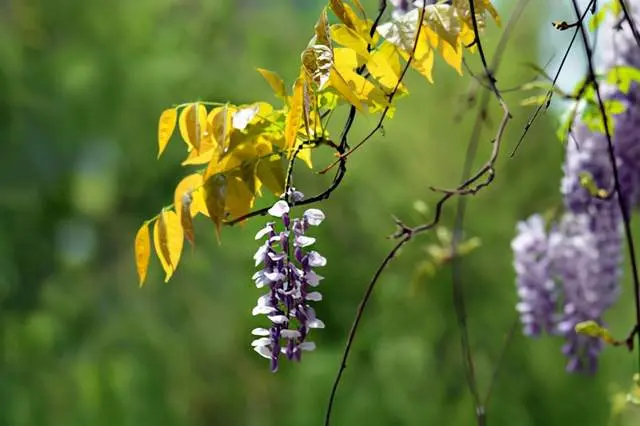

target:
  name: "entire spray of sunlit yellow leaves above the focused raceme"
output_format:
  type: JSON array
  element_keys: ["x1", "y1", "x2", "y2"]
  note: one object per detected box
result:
[{"x1": 135, "y1": 0, "x2": 500, "y2": 284}]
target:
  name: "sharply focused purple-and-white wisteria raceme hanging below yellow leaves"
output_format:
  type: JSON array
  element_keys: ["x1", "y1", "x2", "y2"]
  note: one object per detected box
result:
[{"x1": 251, "y1": 191, "x2": 327, "y2": 372}]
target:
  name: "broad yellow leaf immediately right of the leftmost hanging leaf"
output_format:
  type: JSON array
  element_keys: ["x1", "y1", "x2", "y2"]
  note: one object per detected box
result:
[{"x1": 153, "y1": 210, "x2": 184, "y2": 282}]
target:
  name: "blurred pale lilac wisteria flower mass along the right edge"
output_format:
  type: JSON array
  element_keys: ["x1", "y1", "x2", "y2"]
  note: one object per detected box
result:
[{"x1": 512, "y1": 8, "x2": 640, "y2": 373}]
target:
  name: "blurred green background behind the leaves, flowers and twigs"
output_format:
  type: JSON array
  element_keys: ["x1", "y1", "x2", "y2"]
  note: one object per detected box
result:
[{"x1": 0, "y1": 0, "x2": 639, "y2": 426}]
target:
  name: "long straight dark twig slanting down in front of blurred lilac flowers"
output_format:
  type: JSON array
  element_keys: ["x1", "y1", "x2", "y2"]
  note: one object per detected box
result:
[{"x1": 571, "y1": 0, "x2": 640, "y2": 372}]
